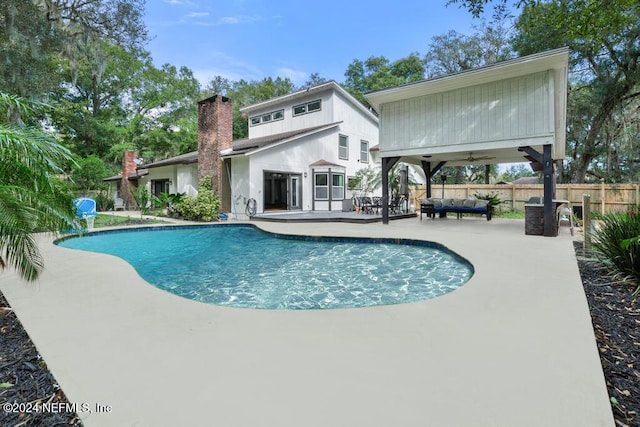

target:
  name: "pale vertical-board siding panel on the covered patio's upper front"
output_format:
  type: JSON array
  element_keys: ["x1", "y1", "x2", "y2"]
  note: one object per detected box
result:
[{"x1": 380, "y1": 71, "x2": 554, "y2": 155}]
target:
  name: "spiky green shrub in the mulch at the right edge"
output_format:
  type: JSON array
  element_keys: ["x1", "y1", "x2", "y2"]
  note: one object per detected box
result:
[{"x1": 591, "y1": 209, "x2": 640, "y2": 294}]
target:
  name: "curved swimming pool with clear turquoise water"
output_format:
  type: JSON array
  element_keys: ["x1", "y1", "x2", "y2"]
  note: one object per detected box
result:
[{"x1": 56, "y1": 224, "x2": 473, "y2": 310}]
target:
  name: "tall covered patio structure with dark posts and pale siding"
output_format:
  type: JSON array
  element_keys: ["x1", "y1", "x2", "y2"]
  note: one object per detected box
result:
[{"x1": 366, "y1": 48, "x2": 569, "y2": 236}]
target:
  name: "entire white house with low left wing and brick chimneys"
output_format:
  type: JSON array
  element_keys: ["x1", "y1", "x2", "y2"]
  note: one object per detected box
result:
[{"x1": 108, "y1": 81, "x2": 378, "y2": 219}]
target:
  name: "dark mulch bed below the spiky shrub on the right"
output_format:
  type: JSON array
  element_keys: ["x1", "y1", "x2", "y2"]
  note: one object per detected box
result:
[{"x1": 574, "y1": 242, "x2": 640, "y2": 427}]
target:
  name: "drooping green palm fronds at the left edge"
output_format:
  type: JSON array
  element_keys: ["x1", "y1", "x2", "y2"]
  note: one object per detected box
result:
[{"x1": 0, "y1": 92, "x2": 77, "y2": 281}]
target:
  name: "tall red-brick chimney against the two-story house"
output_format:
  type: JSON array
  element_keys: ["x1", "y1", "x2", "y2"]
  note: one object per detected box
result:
[{"x1": 198, "y1": 95, "x2": 233, "y2": 198}]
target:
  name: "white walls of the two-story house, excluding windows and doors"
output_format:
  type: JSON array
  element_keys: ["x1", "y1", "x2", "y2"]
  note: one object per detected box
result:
[{"x1": 232, "y1": 83, "x2": 379, "y2": 217}]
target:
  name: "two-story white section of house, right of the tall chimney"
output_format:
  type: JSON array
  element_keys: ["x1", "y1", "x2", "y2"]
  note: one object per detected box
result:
[{"x1": 221, "y1": 81, "x2": 378, "y2": 214}]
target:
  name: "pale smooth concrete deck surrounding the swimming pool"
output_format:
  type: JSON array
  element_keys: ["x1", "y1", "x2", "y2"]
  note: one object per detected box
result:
[{"x1": 0, "y1": 218, "x2": 614, "y2": 427}]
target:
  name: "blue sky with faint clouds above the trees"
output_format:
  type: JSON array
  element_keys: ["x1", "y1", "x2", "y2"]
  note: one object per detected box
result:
[{"x1": 145, "y1": 0, "x2": 478, "y2": 85}]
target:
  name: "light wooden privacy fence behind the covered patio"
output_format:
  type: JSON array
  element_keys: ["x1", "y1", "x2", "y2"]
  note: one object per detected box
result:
[{"x1": 409, "y1": 183, "x2": 640, "y2": 213}]
